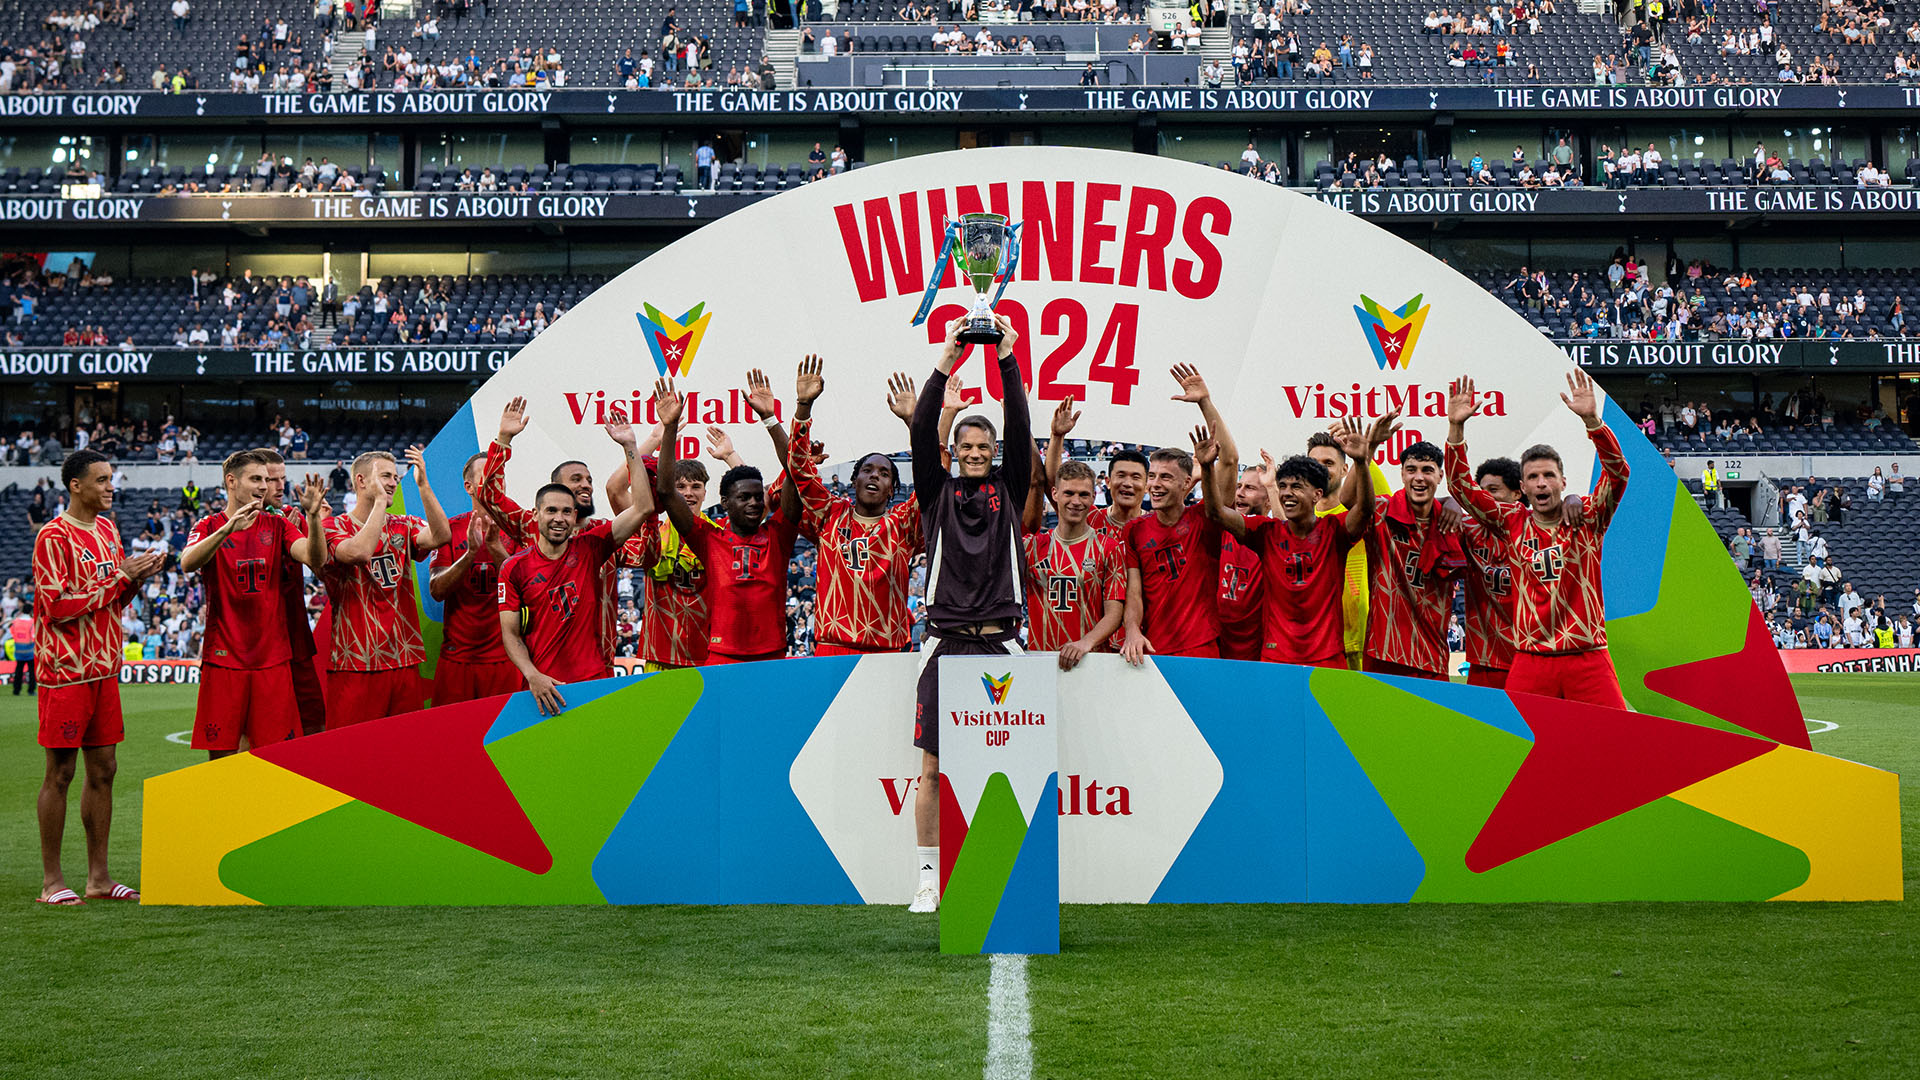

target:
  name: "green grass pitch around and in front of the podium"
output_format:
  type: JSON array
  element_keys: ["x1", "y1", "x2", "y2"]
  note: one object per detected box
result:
[{"x1": 0, "y1": 675, "x2": 1920, "y2": 1080}]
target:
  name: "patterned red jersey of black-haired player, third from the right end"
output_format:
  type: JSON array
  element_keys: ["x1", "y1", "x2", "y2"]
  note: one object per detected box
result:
[{"x1": 1367, "y1": 492, "x2": 1465, "y2": 675}]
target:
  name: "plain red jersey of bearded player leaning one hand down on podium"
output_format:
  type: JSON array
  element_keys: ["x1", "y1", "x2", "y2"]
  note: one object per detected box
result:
[{"x1": 495, "y1": 521, "x2": 614, "y2": 682}]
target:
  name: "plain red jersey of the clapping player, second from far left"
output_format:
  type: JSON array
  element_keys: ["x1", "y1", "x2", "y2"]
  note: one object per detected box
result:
[{"x1": 186, "y1": 513, "x2": 307, "y2": 671}]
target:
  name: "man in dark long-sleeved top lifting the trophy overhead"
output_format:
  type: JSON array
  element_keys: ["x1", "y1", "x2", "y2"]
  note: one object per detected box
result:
[{"x1": 908, "y1": 315, "x2": 1033, "y2": 911}]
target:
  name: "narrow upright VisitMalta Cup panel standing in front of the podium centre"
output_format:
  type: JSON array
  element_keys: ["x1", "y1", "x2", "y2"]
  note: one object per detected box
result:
[{"x1": 936, "y1": 655, "x2": 1081, "y2": 955}]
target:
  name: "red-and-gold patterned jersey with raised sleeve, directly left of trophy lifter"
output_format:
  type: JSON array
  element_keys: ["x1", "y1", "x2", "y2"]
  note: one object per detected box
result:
[{"x1": 787, "y1": 421, "x2": 922, "y2": 650}]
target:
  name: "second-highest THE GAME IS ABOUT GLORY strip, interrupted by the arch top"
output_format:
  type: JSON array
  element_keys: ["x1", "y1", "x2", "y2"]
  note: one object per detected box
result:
[{"x1": 11, "y1": 186, "x2": 1920, "y2": 227}]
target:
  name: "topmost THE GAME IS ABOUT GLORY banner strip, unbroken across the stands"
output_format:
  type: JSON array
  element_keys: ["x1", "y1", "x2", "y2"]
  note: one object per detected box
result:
[{"x1": 0, "y1": 85, "x2": 1920, "y2": 125}]
